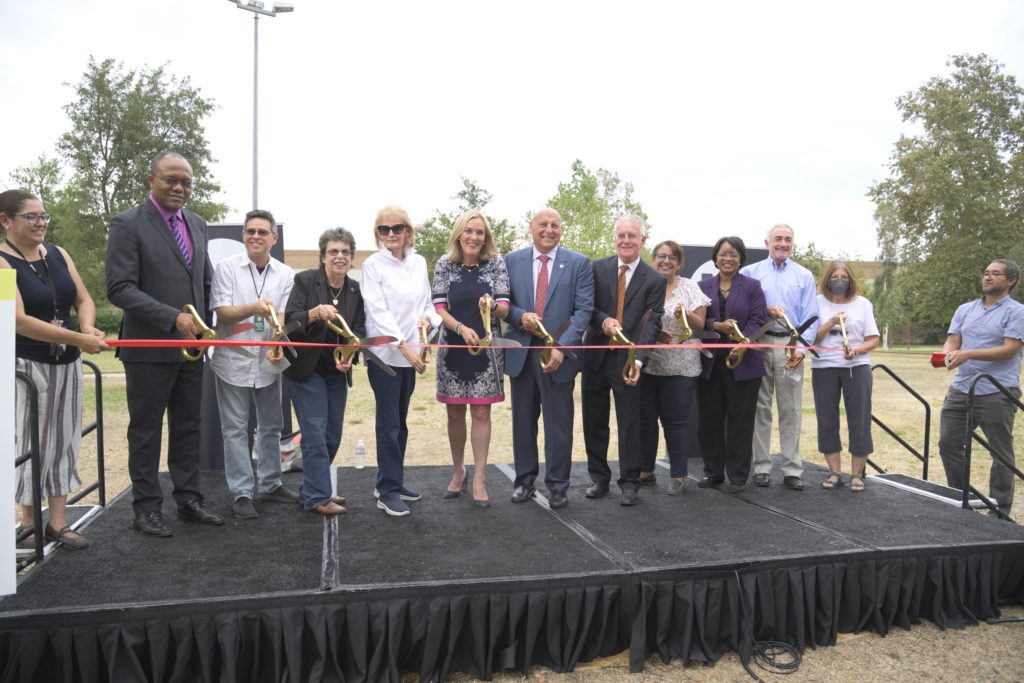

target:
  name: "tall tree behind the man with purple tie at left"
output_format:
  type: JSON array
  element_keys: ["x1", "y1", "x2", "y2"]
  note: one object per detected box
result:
[{"x1": 11, "y1": 57, "x2": 227, "y2": 305}]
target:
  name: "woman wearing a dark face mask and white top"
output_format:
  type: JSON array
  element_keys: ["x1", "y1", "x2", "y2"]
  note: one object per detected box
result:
[{"x1": 811, "y1": 260, "x2": 879, "y2": 492}]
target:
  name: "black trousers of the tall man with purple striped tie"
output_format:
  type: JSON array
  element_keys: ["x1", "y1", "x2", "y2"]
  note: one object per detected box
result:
[{"x1": 125, "y1": 361, "x2": 203, "y2": 514}]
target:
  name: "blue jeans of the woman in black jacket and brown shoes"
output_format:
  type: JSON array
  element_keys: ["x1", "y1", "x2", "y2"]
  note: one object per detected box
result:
[{"x1": 285, "y1": 373, "x2": 348, "y2": 510}]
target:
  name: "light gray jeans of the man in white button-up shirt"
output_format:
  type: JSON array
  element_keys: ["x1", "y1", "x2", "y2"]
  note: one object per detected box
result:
[{"x1": 216, "y1": 377, "x2": 282, "y2": 500}]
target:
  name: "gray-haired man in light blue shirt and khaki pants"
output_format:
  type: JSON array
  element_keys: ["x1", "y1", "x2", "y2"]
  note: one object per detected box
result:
[{"x1": 740, "y1": 223, "x2": 818, "y2": 490}]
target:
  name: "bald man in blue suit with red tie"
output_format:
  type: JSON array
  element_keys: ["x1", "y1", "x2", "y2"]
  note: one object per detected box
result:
[{"x1": 505, "y1": 208, "x2": 594, "y2": 508}]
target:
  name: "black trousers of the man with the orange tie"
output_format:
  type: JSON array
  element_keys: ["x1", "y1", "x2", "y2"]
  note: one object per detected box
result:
[{"x1": 582, "y1": 352, "x2": 646, "y2": 488}]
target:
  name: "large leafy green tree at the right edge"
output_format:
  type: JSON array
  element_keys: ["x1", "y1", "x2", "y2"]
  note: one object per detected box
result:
[{"x1": 867, "y1": 54, "x2": 1024, "y2": 329}]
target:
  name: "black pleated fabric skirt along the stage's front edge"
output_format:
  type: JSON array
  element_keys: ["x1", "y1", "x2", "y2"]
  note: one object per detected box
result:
[{"x1": 0, "y1": 548, "x2": 1024, "y2": 683}]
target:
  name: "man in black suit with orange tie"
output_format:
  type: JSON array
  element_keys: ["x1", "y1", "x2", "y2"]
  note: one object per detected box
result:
[{"x1": 582, "y1": 215, "x2": 665, "y2": 505}]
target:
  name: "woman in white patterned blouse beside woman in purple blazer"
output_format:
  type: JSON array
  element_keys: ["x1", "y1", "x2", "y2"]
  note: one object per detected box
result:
[{"x1": 637, "y1": 240, "x2": 711, "y2": 496}]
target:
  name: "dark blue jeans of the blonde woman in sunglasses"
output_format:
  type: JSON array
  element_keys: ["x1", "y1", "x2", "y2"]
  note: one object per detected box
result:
[{"x1": 367, "y1": 364, "x2": 416, "y2": 501}]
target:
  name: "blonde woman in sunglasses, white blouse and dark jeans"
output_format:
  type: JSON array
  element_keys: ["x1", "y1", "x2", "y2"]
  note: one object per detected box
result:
[{"x1": 359, "y1": 205, "x2": 440, "y2": 517}]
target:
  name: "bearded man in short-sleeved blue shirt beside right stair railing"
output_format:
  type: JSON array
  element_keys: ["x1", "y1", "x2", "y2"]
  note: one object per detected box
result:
[{"x1": 939, "y1": 259, "x2": 1024, "y2": 515}]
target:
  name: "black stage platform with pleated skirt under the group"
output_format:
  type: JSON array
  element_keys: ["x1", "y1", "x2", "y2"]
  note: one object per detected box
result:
[{"x1": 0, "y1": 461, "x2": 1024, "y2": 682}]
